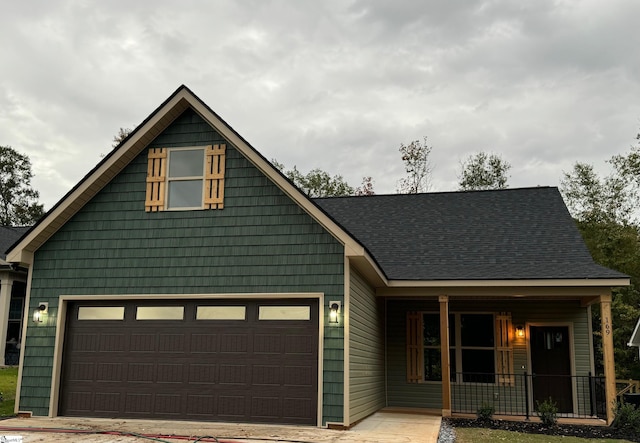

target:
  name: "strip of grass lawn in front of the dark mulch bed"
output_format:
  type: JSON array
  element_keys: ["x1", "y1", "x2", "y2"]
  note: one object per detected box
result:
[{"x1": 456, "y1": 428, "x2": 627, "y2": 443}]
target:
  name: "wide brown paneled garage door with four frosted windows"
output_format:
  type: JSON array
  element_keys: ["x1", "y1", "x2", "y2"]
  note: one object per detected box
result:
[{"x1": 59, "y1": 300, "x2": 318, "y2": 425}]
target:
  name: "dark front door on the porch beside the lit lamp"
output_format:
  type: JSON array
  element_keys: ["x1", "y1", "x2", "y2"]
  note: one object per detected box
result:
[{"x1": 530, "y1": 326, "x2": 573, "y2": 413}]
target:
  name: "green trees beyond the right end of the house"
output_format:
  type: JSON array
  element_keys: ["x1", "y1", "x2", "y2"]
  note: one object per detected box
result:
[{"x1": 560, "y1": 137, "x2": 640, "y2": 378}]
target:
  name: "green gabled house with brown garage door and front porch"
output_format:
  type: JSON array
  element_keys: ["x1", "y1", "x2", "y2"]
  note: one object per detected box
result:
[{"x1": 7, "y1": 86, "x2": 629, "y2": 427}]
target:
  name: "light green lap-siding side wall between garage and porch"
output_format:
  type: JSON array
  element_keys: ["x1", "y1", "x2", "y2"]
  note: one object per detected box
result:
[{"x1": 349, "y1": 270, "x2": 386, "y2": 423}]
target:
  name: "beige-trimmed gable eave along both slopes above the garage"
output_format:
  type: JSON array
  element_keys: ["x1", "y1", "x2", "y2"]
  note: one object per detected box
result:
[{"x1": 6, "y1": 85, "x2": 370, "y2": 272}]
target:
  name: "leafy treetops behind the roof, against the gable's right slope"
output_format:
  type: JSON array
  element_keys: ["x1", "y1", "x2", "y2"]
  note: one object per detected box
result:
[{"x1": 272, "y1": 160, "x2": 355, "y2": 198}]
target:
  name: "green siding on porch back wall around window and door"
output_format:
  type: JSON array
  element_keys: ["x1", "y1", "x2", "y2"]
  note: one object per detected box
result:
[{"x1": 387, "y1": 300, "x2": 591, "y2": 409}]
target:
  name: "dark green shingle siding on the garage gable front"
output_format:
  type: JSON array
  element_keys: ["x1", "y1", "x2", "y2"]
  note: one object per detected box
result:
[{"x1": 20, "y1": 110, "x2": 344, "y2": 422}]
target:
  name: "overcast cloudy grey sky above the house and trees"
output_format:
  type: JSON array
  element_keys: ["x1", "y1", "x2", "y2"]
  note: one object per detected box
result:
[{"x1": 0, "y1": 0, "x2": 640, "y2": 209}]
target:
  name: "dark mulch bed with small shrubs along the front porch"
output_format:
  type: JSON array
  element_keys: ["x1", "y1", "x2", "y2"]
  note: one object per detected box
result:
[{"x1": 443, "y1": 418, "x2": 640, "y2": 442}]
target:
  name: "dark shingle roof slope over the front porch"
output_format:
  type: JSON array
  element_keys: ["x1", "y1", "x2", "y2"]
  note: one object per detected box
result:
[{"x1": 314, "y1": 187, "x2": 626, "y2": 280}]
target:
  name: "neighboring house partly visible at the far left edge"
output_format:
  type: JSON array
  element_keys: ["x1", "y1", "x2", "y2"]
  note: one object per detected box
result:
[{"x1": 0, "y1": 226, "x2": 29, "y2": 366}]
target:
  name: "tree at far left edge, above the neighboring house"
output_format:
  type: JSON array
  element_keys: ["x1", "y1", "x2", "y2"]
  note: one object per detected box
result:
[{"x1": 0, "y1": 146, "x2": 44, "y2": 226}]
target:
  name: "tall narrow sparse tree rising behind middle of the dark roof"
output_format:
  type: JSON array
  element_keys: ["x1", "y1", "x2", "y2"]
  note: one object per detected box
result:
[{"x1": 397, "y1": 137, "x2": 433, "y2": 194}]
